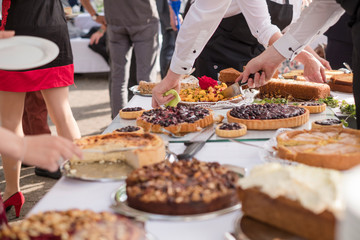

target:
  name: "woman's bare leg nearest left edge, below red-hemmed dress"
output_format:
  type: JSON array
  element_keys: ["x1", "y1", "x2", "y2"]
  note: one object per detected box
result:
[{"x1": 0, "y1": 91, "x2": 26, "y2": 200}]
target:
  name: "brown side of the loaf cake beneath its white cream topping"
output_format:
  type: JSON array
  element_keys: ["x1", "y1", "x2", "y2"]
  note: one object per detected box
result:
[{"x1": 238, "y1": 187, "x2": 336, "y2": 240}]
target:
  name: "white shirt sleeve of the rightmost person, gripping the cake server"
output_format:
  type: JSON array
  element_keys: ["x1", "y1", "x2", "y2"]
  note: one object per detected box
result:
[{"x1": 274, "y1": 0, "x2": 344, "y2": 60}]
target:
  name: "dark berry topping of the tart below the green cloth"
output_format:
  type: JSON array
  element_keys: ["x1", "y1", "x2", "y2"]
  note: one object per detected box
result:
[{"x1": 141, "y1": 106, "x2": 209, "y2": 127}]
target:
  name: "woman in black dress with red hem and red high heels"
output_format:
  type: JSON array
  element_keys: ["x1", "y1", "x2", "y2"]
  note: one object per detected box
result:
[{"x1": 0, "y1": 0, "x2": 81, "y2": 217}]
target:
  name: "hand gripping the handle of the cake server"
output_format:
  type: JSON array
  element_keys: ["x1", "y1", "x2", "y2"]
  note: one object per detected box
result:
[{"x1": 236, "y1": 46, "x2": 285, "y2": 88}]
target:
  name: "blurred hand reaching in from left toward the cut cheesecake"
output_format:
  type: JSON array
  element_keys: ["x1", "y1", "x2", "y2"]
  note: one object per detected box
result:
[{"x1": 20, "y1": 135, "x2": 82, "y2": 172}]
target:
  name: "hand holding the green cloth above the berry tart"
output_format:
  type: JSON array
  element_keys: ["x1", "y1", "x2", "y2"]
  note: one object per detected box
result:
[{"x1": 152, "y1": 70, "x2": 181, "y2": 108}]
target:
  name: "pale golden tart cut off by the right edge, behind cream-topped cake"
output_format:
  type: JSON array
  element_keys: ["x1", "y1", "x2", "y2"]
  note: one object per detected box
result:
[{"x1": 276, "y1": 127, "x2": 360, "y2": 170}]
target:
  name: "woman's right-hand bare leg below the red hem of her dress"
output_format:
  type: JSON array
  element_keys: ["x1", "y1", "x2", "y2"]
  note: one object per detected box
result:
[{"x1": 41, "y1": 87, "x2": 81, "y2": 140}]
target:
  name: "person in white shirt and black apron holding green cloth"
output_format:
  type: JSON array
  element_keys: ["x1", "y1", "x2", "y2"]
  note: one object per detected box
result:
[{"x1": 152, "y1": 0, "x2": 330, "y2": 107}]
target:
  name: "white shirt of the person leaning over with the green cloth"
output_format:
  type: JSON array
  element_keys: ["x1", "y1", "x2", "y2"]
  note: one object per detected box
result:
[{"x1": 170, "y1": 0, "x2": 302, "y2": 74}]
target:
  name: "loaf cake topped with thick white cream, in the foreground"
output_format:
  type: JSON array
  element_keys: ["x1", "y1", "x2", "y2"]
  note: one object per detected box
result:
[{"x1": 238, "y1": 163, "x2": 344, "y2": 239}]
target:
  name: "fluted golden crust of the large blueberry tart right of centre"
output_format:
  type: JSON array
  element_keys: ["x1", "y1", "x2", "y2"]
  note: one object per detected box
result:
[{"x1": 226, "y1": 109, "x2": 310, "y2": 130}]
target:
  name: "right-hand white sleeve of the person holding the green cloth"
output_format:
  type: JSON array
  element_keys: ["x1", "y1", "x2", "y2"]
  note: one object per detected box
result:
[{"x1": 237, "y1": 0, "x2": 281, "y2": 47}]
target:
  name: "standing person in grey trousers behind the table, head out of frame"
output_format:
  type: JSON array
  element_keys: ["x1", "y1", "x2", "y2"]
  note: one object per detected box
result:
[{"x1": 81, "y1": 0, "x2": 159, "y2": 118}]
